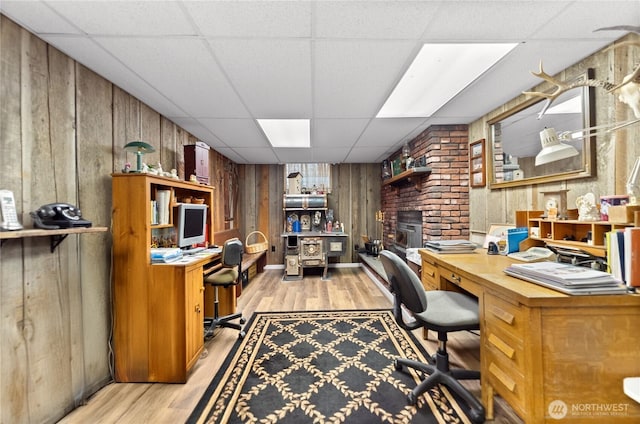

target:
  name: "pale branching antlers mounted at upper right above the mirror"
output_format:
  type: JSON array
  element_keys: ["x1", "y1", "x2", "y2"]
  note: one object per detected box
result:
[{"x1": 523, "y1": 41, "x2": 640, "y2": 119}]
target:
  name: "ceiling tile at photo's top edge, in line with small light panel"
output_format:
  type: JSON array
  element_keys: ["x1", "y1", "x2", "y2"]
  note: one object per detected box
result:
[{"x1": 184, "y1": 1, "x2": 312, "y2": 38}]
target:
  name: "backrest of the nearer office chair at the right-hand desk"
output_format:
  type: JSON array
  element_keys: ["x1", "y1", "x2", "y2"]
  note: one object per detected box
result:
[{"x1": 380, "y1": 250, "x2": 427, "y2": 318}]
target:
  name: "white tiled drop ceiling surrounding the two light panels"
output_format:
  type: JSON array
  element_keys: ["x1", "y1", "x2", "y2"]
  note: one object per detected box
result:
[{"x1": 0, "y1": 0, "x2": 640, "y2": 164}]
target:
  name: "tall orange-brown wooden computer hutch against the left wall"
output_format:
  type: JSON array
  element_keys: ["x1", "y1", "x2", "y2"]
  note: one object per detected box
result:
[{"x1": 112, "y1": 174, "x2": 214, "y2": 383}]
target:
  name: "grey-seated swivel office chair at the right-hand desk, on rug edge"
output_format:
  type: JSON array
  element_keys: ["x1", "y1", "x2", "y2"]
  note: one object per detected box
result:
[{"x1": 380, "y1": 250, "x2": 485, "y2": 423}]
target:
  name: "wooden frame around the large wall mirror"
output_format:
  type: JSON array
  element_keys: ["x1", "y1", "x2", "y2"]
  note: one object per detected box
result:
[{"x1": 487, "y1": 68, "x2": 596, "y2": 190}]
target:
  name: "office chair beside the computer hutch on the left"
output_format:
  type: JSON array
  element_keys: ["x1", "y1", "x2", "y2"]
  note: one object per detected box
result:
[{"x1": 204, "y1": 238, "x2": 245, "y2": 339}]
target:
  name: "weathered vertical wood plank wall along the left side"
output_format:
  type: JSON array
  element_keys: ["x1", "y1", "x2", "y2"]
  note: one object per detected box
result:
[{"x1": 0, "y1": 15, "x2": 238, "y2": 423}]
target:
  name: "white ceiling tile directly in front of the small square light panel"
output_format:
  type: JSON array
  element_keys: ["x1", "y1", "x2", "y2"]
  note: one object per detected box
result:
[{"x1": 211, "y1": 40, "x2": 311, "y2": 119}]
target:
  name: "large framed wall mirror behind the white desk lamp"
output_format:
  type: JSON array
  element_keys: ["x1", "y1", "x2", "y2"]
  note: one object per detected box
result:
[{"x1": 488, "y1": 70, "x2": 596, "y2": 189}]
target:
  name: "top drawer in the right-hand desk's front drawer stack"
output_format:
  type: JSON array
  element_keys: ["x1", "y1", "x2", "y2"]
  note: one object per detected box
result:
[{"x1": 484, "y1": 294, "x2": 527, "y2": 344}]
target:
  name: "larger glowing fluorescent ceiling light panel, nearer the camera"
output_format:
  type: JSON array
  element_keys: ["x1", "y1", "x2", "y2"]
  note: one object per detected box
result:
[{"x1": 377, "y1": 43, "x2": 517, "y2": 118}]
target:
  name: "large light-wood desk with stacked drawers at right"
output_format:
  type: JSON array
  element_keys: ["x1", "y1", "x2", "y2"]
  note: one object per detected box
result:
[{"x1": 420, "y1": 249, "x2": 640, "y2": 423}]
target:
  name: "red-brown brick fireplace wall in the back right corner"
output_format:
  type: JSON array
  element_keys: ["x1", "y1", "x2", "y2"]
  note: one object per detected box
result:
[{"x1": 381, "y1": 125, "x2": 469, "y2": 247}]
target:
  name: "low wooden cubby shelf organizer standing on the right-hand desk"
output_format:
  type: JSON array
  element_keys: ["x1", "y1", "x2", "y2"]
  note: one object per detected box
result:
[{"x1": 516, "y1": 209, "x2": 632, "y2": 258}]
